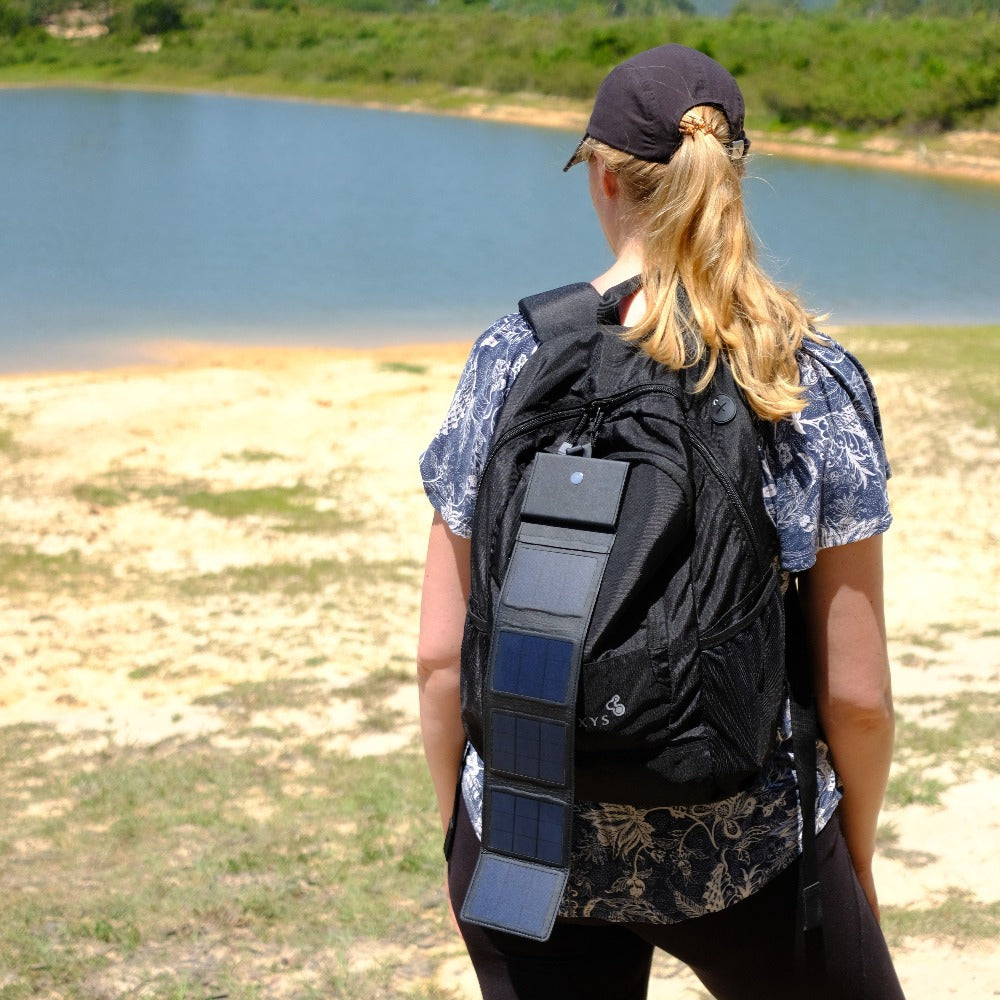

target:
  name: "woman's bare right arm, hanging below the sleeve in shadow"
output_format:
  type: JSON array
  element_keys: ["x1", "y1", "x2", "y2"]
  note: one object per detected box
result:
[{"x1": 801, "y1": 536, "x2": 894, "y2": 916}]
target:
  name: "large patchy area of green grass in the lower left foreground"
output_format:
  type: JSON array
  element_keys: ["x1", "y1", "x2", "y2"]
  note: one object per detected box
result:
[{"x1": 0, "y1": 727, "x2": 446, "y2": 1000}]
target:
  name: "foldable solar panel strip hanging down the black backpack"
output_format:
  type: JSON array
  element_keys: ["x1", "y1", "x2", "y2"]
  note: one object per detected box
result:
[{"x1": 462, "y1": 453, "x2": 628, "y2": 941}]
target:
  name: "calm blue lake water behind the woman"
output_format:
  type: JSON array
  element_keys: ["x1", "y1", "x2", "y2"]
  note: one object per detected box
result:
[{"x1": 0, "y1": 89, "x2": 1000, "y2": 370}]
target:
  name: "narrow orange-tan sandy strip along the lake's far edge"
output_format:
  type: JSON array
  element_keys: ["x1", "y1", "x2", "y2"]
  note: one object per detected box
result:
[{"x1": 7, "y1": 80, "x2": 1000, "y2": 185}]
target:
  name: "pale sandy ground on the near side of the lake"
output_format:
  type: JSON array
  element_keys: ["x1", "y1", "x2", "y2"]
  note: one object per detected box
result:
[{"x1": 0, "y1": 345, "x2": 1000, "y2": 1000}]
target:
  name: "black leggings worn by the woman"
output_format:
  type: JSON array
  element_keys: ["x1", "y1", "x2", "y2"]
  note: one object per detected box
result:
[{"x1": 448, "y1": 804, "x2": 903, "y2": 1000}]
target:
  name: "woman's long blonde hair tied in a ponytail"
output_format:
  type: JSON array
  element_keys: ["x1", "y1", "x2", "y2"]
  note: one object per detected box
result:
[{"x1": 581, "y1": 106, "x2": 813, "y2": 420}]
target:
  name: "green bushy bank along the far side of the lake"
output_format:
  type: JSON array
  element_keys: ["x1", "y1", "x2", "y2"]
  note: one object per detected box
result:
[{"x1": 0, "y1": 0, "x2": 1000, "y2": 135}]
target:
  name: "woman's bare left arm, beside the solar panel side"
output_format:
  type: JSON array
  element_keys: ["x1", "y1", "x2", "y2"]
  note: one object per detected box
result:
[{"x1": 417, "y1": 514, "x2": 470, "y2": 829}]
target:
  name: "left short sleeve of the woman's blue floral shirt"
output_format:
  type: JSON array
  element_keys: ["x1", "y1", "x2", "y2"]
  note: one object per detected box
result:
[{"x1": 420, "y1": 313, "x2": 538, "y2": 538}]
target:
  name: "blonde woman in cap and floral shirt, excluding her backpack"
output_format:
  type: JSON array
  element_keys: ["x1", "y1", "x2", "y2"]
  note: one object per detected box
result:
[{"x1": 418, "y1": 45, "x2": 902, "y2": 1000}]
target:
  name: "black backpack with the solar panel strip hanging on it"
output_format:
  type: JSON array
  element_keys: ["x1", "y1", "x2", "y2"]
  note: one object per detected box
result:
[{"x1": 461, "y1": 280, "x2": 815, "y2": 939}]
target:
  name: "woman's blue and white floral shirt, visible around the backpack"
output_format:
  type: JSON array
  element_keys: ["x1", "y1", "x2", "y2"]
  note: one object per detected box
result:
[{"x1": 420, "y1": 314, "x2": 892, "y2": 923}]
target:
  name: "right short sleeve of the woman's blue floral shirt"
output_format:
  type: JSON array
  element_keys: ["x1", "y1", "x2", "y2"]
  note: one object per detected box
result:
[{"x1": 761, "y1": 336, "x2": 892, "y2": 572}]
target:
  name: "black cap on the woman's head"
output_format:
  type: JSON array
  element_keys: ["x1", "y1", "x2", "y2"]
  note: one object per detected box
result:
[{"x1": 563, "y1": 45, "x2": 750, "y2": 170}]
